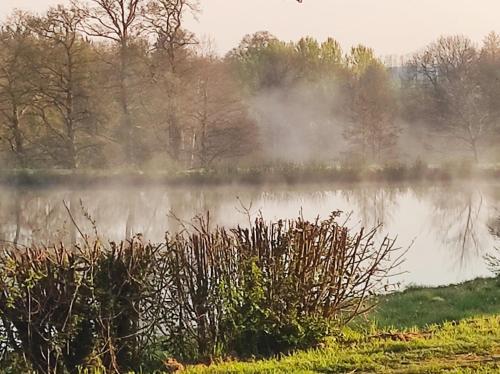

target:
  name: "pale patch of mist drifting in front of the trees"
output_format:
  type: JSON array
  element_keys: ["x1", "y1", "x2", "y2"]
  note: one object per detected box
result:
[{"x1": 250, "y1": 82, "x2": 347, "y2": 163}]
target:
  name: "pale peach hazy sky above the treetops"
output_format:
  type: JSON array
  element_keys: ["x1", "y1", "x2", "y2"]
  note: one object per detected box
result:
[{"x1": 0, "y1": 0, "x2": 500, "y2": 55}]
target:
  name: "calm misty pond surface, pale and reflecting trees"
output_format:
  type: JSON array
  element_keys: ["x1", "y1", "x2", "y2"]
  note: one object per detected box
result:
[{"x1": 0, "y1": 183, "x2": 500, "y2": 285}]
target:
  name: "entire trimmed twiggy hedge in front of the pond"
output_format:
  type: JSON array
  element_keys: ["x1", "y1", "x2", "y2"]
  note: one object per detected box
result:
[{"x1": 0, "y1": 212, "x2": 399, "y2": 373}]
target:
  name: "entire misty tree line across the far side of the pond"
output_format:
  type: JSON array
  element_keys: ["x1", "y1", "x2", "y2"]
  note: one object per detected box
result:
[{"x1": 0, "y1": 0, "x2": 500, "y2": 169}]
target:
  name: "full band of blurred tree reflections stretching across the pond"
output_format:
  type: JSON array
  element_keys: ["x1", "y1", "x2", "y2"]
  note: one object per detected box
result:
[{"x1": 0, "y1": 185, "x2": 492, "y2": 265}]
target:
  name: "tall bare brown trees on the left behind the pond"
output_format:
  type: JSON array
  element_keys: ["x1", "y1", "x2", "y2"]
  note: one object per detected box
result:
[{"x1": 0, "y1": 0, "x2": 253, "y2": 169}]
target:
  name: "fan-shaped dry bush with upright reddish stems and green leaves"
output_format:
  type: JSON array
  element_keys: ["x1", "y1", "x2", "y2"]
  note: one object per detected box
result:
[{"x1": 166, "y1": 212, "x2": 401, "y2": 358}]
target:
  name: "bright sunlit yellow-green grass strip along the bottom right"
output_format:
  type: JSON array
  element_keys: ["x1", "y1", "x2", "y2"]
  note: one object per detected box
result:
[{"x1": 187, "y1": 316, "x2": 500, "y2": 374}]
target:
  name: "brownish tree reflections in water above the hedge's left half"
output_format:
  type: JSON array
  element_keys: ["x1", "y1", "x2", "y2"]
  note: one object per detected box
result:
[{"x1": 0, "y1": 187, "x2": 244, "y2": 245}]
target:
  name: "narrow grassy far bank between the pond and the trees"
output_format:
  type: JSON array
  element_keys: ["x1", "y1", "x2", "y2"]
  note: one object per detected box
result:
[{"x1": 0, "y1": 164, "x2": 500, "y2": 186}]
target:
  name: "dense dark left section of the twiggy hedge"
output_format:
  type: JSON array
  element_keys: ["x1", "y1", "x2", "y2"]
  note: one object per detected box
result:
[{"x1": 0, "y1": 238, "x2": 170, "y2": 373}]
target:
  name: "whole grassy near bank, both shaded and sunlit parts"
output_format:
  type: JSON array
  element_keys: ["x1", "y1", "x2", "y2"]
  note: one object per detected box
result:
[{"x1": 187, "y1": 279, "x2": 500, "y2": 374}]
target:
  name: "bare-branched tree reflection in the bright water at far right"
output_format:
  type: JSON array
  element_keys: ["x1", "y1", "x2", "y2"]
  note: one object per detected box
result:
[{"x1": 430, "y1": 186, "x2": 487, "y2": 268}]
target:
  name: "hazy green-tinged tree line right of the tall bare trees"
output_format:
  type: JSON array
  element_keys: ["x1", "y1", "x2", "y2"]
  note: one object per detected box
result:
[{"x1": 228, "y1": 32, "x2": 500, "y2": 163}]
